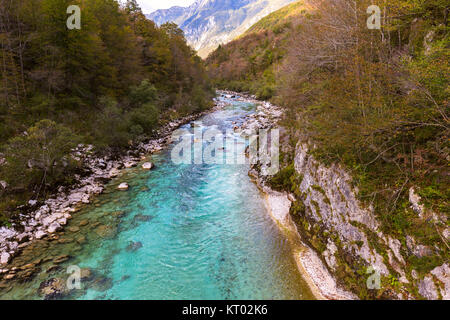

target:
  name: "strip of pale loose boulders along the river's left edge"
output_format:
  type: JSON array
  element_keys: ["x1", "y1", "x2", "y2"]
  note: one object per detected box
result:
[{"x1": 0, "y1": 100, "x2": 229, "y2": 268}]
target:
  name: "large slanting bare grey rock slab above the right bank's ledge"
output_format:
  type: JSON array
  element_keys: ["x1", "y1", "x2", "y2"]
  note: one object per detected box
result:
[{"x1": 295, "y1": 144, "x2": 388, "y2": 276}]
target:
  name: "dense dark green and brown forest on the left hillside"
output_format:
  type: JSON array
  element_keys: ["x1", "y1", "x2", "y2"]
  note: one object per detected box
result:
[{"x1": 0, "y1": 0, "x2": 214, "y2": 224}]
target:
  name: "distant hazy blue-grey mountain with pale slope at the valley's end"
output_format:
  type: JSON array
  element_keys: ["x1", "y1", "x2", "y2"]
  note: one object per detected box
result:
[{"x1": 147, "y1": 0, "x2": 294, "y2": 57}]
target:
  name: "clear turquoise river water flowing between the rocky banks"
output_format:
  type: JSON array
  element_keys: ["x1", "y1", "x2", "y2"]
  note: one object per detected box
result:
[{"x1": 0, "y1": 100, "x2": 313, "y2": 299}]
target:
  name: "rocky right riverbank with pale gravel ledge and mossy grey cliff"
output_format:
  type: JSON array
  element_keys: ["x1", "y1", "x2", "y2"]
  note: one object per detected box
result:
[{"x1": 234, "y1": 92, "x2": 450, "y2": 300}]
